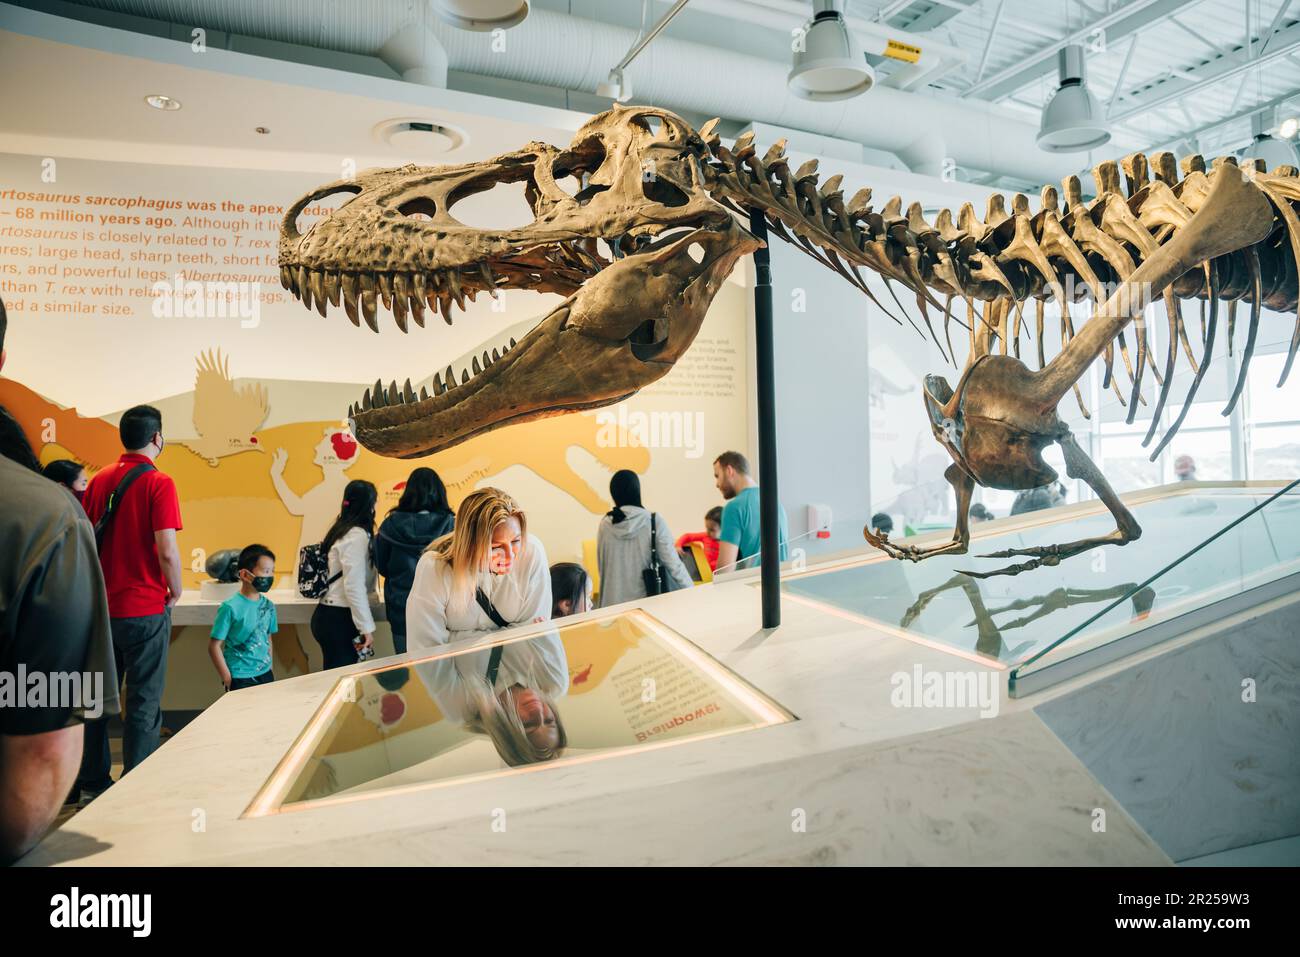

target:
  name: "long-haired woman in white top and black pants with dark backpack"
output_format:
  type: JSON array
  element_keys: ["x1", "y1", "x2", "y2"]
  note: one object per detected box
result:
[{"x1": 312, "y1": 479, "x2": 378, "y2": 670}]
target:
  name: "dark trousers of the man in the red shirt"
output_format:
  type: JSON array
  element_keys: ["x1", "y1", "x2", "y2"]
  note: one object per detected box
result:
[{"x1": 77, "y1": 611, "x2": 172, "y2": 793}]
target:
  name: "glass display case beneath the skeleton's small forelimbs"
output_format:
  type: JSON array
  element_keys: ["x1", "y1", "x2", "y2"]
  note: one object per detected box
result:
[{"x1": 781, "y1": 482, "x2": 1300, "y2": 693}]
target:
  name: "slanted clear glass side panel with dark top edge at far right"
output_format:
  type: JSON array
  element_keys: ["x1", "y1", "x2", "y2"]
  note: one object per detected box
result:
[{"x1": 1010, "y1": 480, "x2": 1300, "y2": 693}]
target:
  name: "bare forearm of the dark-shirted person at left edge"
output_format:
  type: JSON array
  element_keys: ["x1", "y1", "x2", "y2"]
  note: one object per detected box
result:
[{"x1": 0, "y1": 724, "x2": 86, "y2": 866}]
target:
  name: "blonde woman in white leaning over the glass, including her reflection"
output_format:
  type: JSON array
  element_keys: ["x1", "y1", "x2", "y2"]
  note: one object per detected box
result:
[{"x1": 407, "y1": 488, "x2": 568, "y2": 765}]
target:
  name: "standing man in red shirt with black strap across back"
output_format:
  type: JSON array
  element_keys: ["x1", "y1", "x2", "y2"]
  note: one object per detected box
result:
[{"x1": 78, "y1": 406, "x2": 181, "y2": 801}]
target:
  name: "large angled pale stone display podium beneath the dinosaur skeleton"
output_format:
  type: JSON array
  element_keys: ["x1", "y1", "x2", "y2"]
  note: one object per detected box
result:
[{"x1": 22, "y1": 482, "x2": 1300, "y2": 866}]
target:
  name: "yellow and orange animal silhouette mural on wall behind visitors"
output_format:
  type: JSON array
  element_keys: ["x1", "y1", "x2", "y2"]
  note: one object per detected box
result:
[{"x1": 0, "y1": 351, "x2": 650, "y2": 588}]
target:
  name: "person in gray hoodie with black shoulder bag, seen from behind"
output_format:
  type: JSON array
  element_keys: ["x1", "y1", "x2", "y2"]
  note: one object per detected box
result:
[{"x1": 595, "y1": 468, "x2": 692, "y2": 609}]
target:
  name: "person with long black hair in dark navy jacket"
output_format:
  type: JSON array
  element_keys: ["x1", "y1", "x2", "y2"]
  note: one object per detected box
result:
[{"x1": 374, "y1": 468, "x2": 456, "y2": 654}]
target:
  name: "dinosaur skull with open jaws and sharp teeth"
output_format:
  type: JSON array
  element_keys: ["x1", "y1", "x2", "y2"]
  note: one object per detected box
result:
[{"x1": 280, "y1": 107, "x2": 759, "y2": 458}]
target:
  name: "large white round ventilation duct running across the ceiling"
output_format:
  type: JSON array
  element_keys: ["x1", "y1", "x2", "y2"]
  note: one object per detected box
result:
[{"x1": 45, "y1": 0, "x2": 1102, "y2": 183}]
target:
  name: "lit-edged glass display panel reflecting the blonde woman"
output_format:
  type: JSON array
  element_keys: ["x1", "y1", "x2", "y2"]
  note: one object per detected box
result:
[{"x1": 244, "y1": 610, "x2": 793, "y2": 817}]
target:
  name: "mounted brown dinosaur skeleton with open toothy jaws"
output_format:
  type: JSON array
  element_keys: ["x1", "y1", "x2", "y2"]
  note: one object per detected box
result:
[{"x1": 280, "y1": 105, "x2": 1300, "y2": 573}]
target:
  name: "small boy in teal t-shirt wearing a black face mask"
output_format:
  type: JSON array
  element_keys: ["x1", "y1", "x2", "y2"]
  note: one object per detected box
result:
[{"x1": 208, "y1": 545, "x2": 280, "y2": 692}]
